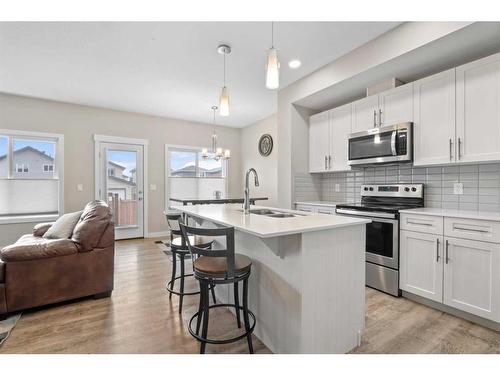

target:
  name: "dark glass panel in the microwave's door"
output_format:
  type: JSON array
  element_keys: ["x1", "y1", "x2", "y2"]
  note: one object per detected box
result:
[{"x1": 349, "y1": 131, "x2": 392, "y2": 160}]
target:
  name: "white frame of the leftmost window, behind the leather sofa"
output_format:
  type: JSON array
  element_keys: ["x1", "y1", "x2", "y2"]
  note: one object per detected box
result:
[{"x1": 0, "y1": 129, "x2": 64, "y2": 224}]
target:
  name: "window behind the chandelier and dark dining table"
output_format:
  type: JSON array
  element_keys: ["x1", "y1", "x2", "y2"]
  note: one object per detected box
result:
[{"x1": 166, "y1": 146, "x2": 227, "y2": 204}]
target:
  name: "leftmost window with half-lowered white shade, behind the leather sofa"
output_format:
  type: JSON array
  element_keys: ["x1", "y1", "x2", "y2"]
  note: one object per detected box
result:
[{"x1": 0, "y1": 129, "x2": 64, "y2": 222}]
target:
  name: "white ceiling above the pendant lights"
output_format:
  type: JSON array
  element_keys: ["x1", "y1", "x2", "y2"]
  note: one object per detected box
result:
[{"x1": 0, "y1": 22, "x2": 398, "y2": 127}]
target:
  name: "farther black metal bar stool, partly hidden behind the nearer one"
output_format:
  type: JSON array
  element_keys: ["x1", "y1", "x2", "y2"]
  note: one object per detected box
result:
[{"x1": 165, "y1": 212, "x2": 215, "y2": 314}]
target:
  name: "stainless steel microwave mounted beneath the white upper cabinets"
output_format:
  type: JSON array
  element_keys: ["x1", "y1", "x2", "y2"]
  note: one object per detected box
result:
[{"x1": 348, "y1": 122, "x2": 413, "y2": 165}]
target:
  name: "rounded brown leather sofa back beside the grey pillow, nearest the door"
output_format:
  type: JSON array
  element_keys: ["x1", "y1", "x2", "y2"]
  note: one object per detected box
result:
[{"x1": 71, "y1": 200, "x2": 112, "y2": 252}]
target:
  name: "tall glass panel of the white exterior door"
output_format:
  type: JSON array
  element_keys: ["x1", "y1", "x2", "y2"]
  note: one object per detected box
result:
[{"x1": 106, "y1": 150, "x2": 137, "y2": 228}]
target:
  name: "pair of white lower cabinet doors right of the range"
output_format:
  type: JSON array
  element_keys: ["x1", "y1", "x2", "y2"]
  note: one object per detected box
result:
[{"x1": 399, "y1": 214, "x2": 500, "y2": 322}]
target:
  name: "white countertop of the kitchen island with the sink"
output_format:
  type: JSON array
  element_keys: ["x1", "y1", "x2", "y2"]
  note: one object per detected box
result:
[{"x1": 175, "y1": 204, "x2": 371, "y2": 237}]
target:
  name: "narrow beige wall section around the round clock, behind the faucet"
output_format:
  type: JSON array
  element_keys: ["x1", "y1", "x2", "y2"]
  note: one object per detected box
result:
[{"x1": 240, "y1": 114, "x2": 278, "y2": 207}]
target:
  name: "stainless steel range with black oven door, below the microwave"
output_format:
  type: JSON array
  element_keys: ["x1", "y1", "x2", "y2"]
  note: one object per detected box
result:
[{"x1": 335, "y1": 184, "x2": 424, "y2": 296}]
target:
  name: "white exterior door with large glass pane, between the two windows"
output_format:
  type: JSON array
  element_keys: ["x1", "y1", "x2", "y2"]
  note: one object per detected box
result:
[{"x1": 99, "y1": 142, "x2": 144, "y2": 240}]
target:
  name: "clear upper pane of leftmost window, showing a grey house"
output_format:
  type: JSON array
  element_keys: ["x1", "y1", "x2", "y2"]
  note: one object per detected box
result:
[{"x1": 11, "y1": 138, "x2": 56, "y2": 180}]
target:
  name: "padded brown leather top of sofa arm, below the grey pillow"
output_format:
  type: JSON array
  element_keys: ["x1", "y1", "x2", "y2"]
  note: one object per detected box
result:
[{"x1": 0, "y1": 234, "x2": 78, "y2": 263}]
